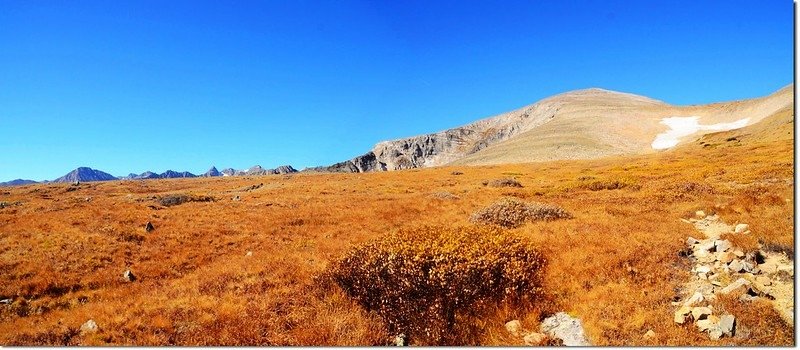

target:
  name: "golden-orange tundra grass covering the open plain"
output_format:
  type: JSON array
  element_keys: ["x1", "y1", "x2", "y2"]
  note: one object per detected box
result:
[{"x1": 0, "y1": 130, "x2": 794, "y2": 345}]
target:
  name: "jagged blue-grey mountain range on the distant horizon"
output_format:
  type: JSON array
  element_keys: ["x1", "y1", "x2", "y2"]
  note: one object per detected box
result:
[{"x1": 0, "y1": 165, "x2": 297, "y2": 187}]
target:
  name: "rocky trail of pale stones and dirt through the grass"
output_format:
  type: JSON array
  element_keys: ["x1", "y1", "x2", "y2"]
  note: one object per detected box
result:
[{"x1": 673, "y1": 211, "x2": 794, "y2": 340}]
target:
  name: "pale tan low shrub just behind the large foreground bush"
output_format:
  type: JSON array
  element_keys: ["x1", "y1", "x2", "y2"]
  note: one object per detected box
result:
[{"x1": 470, "y1": 198, "x2": 572, "y2": 228}]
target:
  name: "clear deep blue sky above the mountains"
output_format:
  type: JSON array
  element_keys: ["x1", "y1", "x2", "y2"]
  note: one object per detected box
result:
[{"x1": 0, "y1": 0, "x2": 793, "y2": 181}]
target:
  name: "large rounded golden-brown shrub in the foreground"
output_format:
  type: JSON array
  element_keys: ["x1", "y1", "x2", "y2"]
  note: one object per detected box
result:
[{"x1": 331, "y1": 226, "x2": 545, "y2": 345}]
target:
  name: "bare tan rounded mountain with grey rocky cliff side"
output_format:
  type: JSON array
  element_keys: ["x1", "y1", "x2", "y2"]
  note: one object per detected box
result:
[{"x1": 316, "y1": 85, "x2": 793, "y2": 172}]
